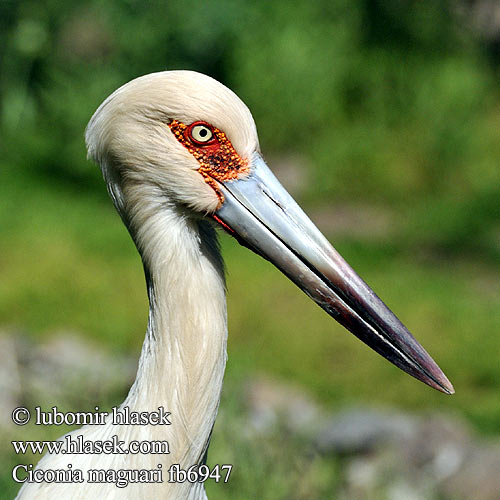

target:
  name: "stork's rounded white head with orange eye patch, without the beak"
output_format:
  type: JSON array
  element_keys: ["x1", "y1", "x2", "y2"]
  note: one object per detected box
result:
[{"x1": 86, "y1": 71, "x2": 259, "y2": 214}]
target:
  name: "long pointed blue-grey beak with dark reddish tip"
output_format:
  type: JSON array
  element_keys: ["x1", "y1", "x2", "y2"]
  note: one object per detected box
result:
[{"x1": 213, "y1": 153, "x2": 455, "y2": 394}]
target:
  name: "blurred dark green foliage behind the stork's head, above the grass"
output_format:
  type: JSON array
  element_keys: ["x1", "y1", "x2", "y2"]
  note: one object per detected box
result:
[{"x1": 0, "y1": 0, "x2": 500, "y2": 262}]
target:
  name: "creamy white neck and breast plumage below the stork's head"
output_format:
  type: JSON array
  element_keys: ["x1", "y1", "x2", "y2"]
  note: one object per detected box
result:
[{"x1": 17, "y1": 184, "x2": 227, "y2": 500}]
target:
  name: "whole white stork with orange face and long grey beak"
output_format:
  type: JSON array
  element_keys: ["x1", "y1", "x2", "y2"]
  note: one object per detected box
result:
[{"x1": 17, "y1": 71, "x2": 454, "y2": 500}]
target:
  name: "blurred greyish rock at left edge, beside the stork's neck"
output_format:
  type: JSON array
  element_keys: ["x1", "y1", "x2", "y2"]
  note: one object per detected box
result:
[{"x1": 0, "y1": 333, "x2": 136, "y2": 416}]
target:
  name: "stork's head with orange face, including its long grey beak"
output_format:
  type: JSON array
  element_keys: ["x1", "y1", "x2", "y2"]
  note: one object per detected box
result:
[{"x1": 86, "y1": 71, "x2": 454, "y2": 394}]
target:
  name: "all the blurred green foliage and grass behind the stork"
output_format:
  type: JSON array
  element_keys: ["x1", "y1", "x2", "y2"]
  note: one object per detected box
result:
[{"x1": 0, "y1": 0, "x2": 500, "y2": 498}]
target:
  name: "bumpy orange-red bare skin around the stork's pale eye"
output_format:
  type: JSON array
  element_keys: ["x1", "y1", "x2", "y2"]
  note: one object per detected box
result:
[{"x1": 168, "y1": 120, "x2": 250, "y2": 204}]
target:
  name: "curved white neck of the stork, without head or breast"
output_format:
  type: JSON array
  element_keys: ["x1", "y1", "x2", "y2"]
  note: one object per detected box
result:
[{"x1": 123, "y1": 184, "x2": 227, "y2": 470}]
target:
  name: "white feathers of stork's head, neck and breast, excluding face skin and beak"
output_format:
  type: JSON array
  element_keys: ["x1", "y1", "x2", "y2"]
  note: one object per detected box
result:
[{"x1": 17, "y1": 71, "x2": 259, "y2": 500}]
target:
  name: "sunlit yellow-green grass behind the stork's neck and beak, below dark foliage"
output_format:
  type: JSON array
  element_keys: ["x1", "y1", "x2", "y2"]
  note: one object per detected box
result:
[{"x1": 0, "y1": 168, "x2": 500, "y2": 499}]
